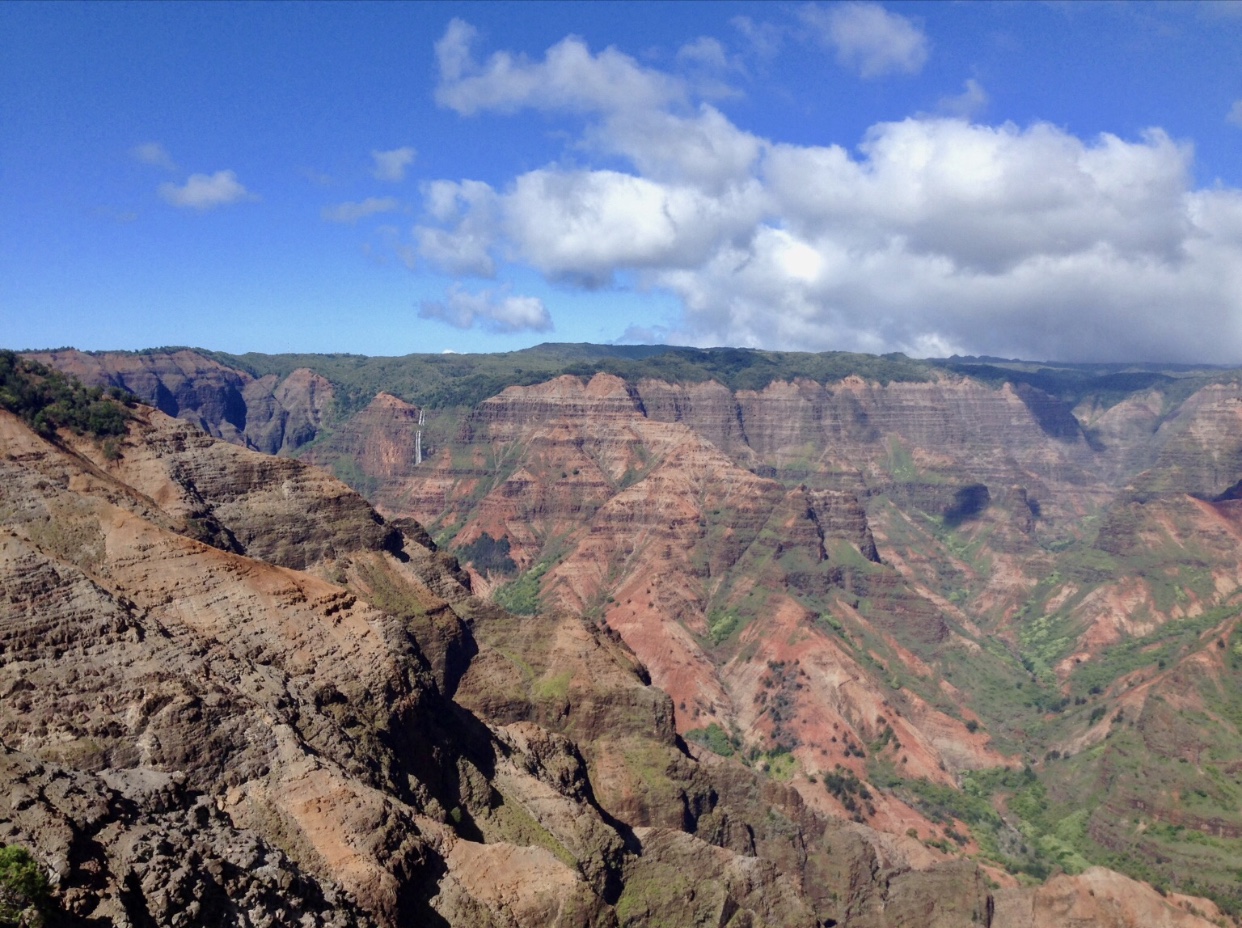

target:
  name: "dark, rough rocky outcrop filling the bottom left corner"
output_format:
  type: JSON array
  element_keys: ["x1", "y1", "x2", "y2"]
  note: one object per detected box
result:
[{"x1": 0, "y1": 744, "x2": 374, "y2": 928}]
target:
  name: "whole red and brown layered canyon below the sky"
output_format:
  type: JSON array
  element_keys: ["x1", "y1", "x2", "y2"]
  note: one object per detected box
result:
[{"x1": 9, "y1": 347, "x2": 1242, "y2": 928}]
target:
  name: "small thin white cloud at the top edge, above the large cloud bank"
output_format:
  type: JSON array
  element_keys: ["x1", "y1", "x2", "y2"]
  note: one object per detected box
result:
[{"x1": 799, "y1": 2, "x2": 929, "y2": 78}]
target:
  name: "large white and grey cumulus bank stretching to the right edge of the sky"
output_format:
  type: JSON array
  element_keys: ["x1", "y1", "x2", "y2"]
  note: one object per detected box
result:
[{"x1": 415, "y1": 20, "x2": 1242, "y2": 363}]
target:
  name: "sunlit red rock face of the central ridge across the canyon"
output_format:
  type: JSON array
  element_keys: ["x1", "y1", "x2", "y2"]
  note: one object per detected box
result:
[{"x1": 361, "y1": 375, "x2": 1025, "y2": 830}]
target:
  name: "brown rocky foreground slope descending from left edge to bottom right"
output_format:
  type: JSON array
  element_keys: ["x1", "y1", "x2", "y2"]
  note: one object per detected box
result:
[{"x1": 0, "y1": 380, "x2": 1018, "y2": 927}]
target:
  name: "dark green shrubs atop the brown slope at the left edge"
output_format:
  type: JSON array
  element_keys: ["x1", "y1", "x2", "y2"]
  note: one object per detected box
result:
[{"x1": 0, "y1": 350, "x2": 134, "y2": 439}]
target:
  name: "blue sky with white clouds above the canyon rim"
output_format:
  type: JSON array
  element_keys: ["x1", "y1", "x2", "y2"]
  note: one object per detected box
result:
[{"x1": 0, "y1": 0, "x2": 1242, "y2": 364}]
